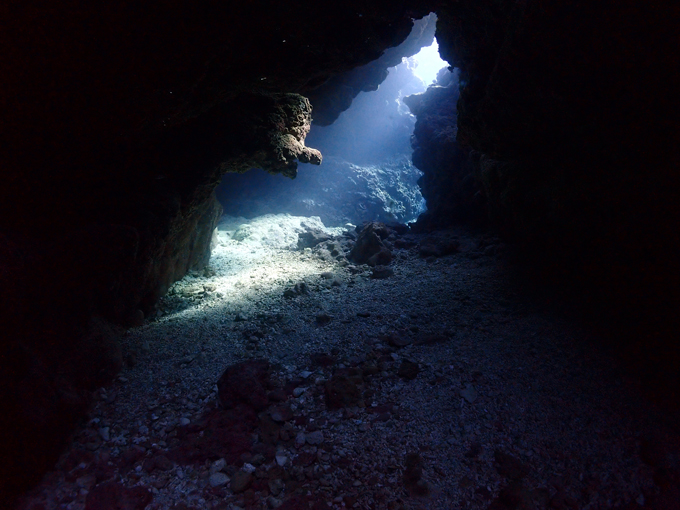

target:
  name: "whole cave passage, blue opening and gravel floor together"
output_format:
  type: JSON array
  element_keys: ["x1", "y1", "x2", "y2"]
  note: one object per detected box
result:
[{"x1": 7, "y1": 4, "x2": 680, "y2": 510}]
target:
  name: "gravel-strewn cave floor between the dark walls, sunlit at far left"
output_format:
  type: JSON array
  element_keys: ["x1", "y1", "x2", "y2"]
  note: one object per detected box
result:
[{"x1": 19, "y1": 216, "x2": 680, "y2": 510}]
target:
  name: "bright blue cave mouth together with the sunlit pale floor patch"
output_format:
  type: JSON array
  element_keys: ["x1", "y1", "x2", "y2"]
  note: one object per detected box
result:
[{"x1": 153, "y1": 14, "x2": 458, "y2": 317}]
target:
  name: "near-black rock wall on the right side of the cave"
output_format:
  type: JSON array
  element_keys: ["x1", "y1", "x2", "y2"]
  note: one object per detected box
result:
[{"x1": 415, "y1": 0, "x2": 680, "y2": 376}]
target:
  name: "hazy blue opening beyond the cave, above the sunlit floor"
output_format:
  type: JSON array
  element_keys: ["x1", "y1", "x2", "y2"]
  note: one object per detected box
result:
[{"x1": 217, "y1": 32, "x2": 457, "y2": 231}]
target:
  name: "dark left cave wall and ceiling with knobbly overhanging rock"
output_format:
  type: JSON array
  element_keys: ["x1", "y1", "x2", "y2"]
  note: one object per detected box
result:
[{"x1": 0, "y1": 1, "x2": 429, "y2": 501}]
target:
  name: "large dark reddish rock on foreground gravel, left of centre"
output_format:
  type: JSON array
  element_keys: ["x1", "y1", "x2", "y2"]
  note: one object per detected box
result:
[{"x1": 217, "y1": 360, "x2": 270, "y2": 411}]
